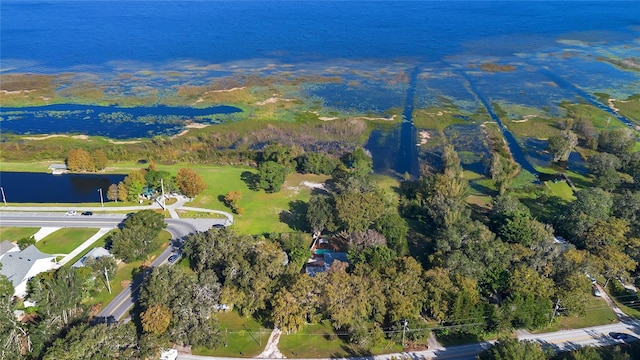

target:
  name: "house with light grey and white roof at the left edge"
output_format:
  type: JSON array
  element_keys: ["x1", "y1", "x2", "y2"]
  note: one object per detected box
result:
[{"x1": 0, "y1": 245, "x2": 59, "y2": 297}]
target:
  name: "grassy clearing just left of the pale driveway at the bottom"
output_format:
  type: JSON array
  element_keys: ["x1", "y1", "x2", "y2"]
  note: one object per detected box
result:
[{"x1": 191, "y1": 311, "x2": 271, "y2": 357}]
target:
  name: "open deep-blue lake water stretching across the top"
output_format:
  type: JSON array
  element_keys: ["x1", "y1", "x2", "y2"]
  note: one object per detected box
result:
[{"x1": 0, "y1": 0, "x2": 640, "y2": 72}]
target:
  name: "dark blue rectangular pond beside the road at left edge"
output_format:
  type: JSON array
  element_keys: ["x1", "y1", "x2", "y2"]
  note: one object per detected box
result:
[{"x1": 0, "y1": 172, "x2": 126, "y2": 203}]
